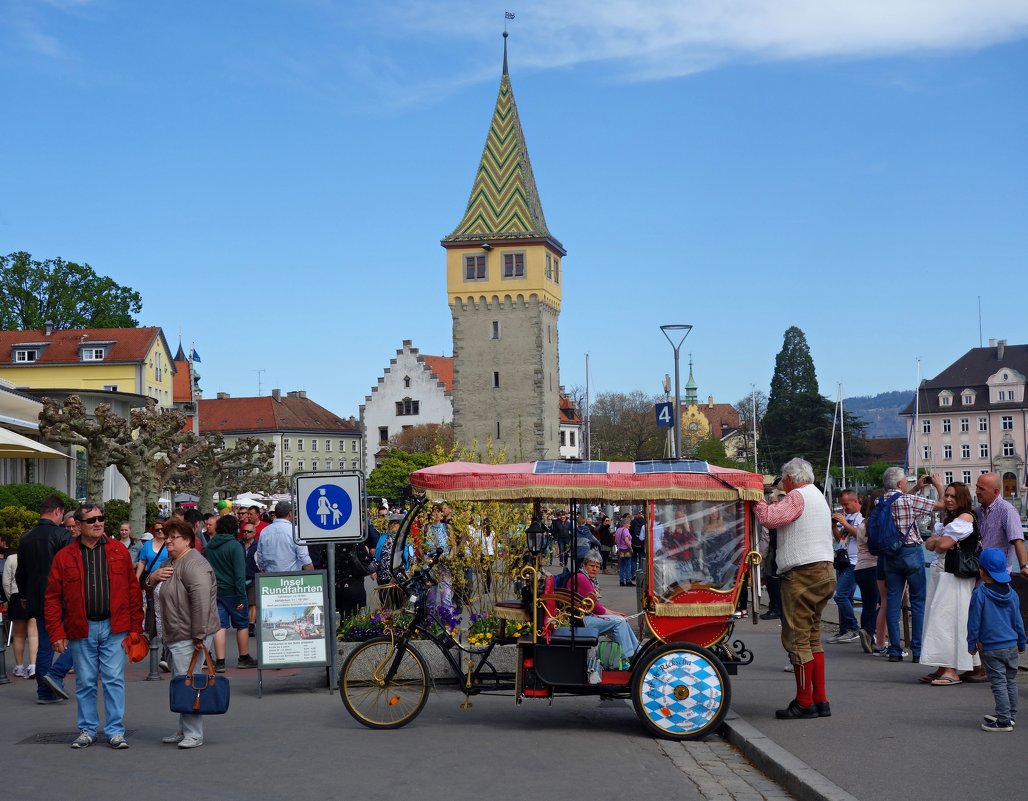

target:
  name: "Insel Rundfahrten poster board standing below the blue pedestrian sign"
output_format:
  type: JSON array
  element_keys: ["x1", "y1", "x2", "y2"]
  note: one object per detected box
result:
[{"x1": 254, "y1": 571, "x2": 335, "y2": 669}]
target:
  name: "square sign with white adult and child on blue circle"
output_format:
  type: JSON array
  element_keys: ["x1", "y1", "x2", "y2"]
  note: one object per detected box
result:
[{"x1": 293, "y1": 473, "x2": 365, "y2": 542}]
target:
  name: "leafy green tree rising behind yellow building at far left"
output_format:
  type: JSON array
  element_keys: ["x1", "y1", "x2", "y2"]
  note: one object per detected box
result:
[{"x1": 0, "y1": 251, "x2": 143, "y2": 331}]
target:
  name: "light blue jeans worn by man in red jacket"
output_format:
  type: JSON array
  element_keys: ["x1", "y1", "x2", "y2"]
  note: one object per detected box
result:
[{"x1": 68, "y1": 619, "x2": 127, "y2": 738}]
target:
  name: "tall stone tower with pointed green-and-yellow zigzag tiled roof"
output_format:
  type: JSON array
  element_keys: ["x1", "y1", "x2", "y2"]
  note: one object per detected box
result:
[{"x1": 442, "y1": 32, "x2": 565, "y2": 462}]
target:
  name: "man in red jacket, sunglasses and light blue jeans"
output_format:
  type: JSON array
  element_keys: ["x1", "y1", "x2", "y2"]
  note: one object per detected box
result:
[{"x1": 45, "y1": 503, "x2": 143, "y2": 750}]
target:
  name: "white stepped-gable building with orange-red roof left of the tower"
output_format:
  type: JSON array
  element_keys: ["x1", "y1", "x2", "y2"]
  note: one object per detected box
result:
[{"x1": 361, "y1": 339, "x2": 453, "y2": 473}]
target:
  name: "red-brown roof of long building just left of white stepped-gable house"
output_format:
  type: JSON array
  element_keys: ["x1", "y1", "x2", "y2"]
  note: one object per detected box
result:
[{"x1": 198, "y1": 396, "x2": 360, "y2": 434}]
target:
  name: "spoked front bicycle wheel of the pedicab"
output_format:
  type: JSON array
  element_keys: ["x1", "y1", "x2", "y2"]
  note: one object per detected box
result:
[{"x1": 339, "y1": 636, "x2": 429, "y2": 729}]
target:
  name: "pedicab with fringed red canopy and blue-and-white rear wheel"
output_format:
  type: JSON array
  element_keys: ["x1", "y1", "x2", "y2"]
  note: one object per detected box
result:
[{"x1": 339, "y1": 460, "x2": 763, "y2": 739}]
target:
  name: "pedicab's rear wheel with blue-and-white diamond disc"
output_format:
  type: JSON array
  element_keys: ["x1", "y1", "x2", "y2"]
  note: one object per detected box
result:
[{"x1": 632, "y1": 643, "x2": 732, "y2": 739}]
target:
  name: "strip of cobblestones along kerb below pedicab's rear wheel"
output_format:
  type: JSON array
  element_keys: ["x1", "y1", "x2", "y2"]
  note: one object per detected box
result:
[{"x1": 657, "y1": 737, "x2": 794, "y2": 801}]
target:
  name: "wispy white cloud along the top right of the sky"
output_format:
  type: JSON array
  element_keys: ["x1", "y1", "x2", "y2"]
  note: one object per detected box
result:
[{"x1": 371, "y1": 0, "x2": 1028, "y2": 80}]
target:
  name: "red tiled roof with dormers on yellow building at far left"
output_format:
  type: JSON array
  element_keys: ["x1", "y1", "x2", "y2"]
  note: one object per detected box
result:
[{"x1": 0, "y1": 326, "x2": 164, "y2": 365}]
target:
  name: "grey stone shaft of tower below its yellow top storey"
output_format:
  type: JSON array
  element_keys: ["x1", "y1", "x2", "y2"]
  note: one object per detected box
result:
[{"x1": 450, "y1": 295, "x2": 560, "y2": 462}]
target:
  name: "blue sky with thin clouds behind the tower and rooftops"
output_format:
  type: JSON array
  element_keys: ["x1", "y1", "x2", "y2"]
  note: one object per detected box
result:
[{"x1": 0, "y1": 0, "x2": 1028, "y2": 416}]
